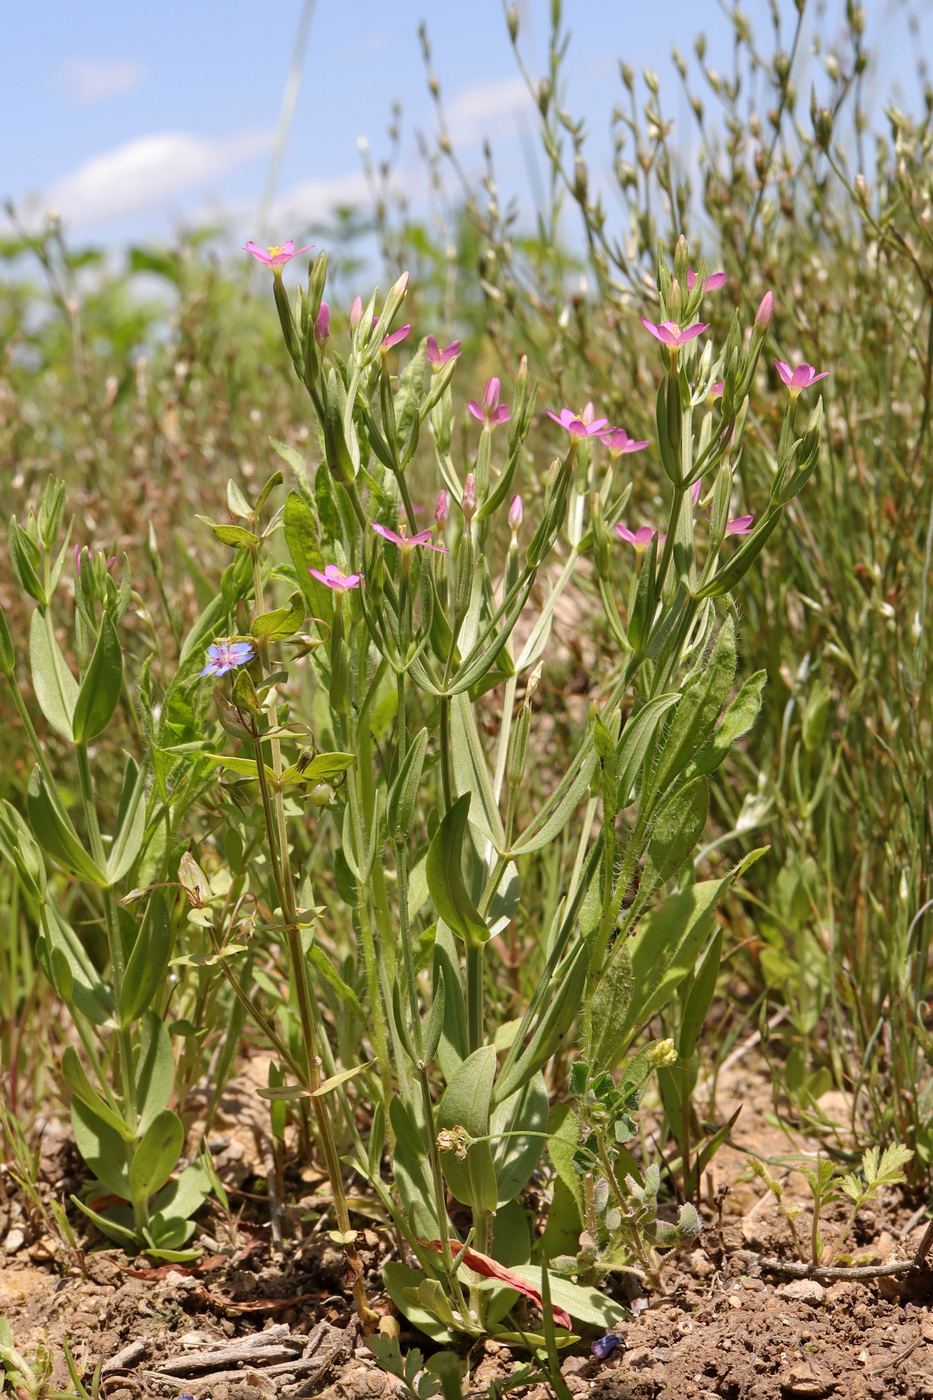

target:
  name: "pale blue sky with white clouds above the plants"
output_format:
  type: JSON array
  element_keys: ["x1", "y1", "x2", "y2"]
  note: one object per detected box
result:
[{"x1": 0, "y1": 0, "x2": 933, "y2": 245}]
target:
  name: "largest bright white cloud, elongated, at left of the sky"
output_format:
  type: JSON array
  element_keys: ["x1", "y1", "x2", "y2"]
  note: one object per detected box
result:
[{"x1": 48, "y1": 132, "x2": 272, "y2": 228}]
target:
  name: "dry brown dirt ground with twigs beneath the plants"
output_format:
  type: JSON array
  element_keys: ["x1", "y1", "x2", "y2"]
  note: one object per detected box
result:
[{"x1": 0, "y1": 1064, "x2": 933, "y2": 1400}]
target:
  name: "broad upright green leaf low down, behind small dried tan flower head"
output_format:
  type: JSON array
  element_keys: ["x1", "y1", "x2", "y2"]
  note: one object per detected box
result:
[{"x1": 437, "y1": 1046, "x2": 499, "y2": 1211}]
